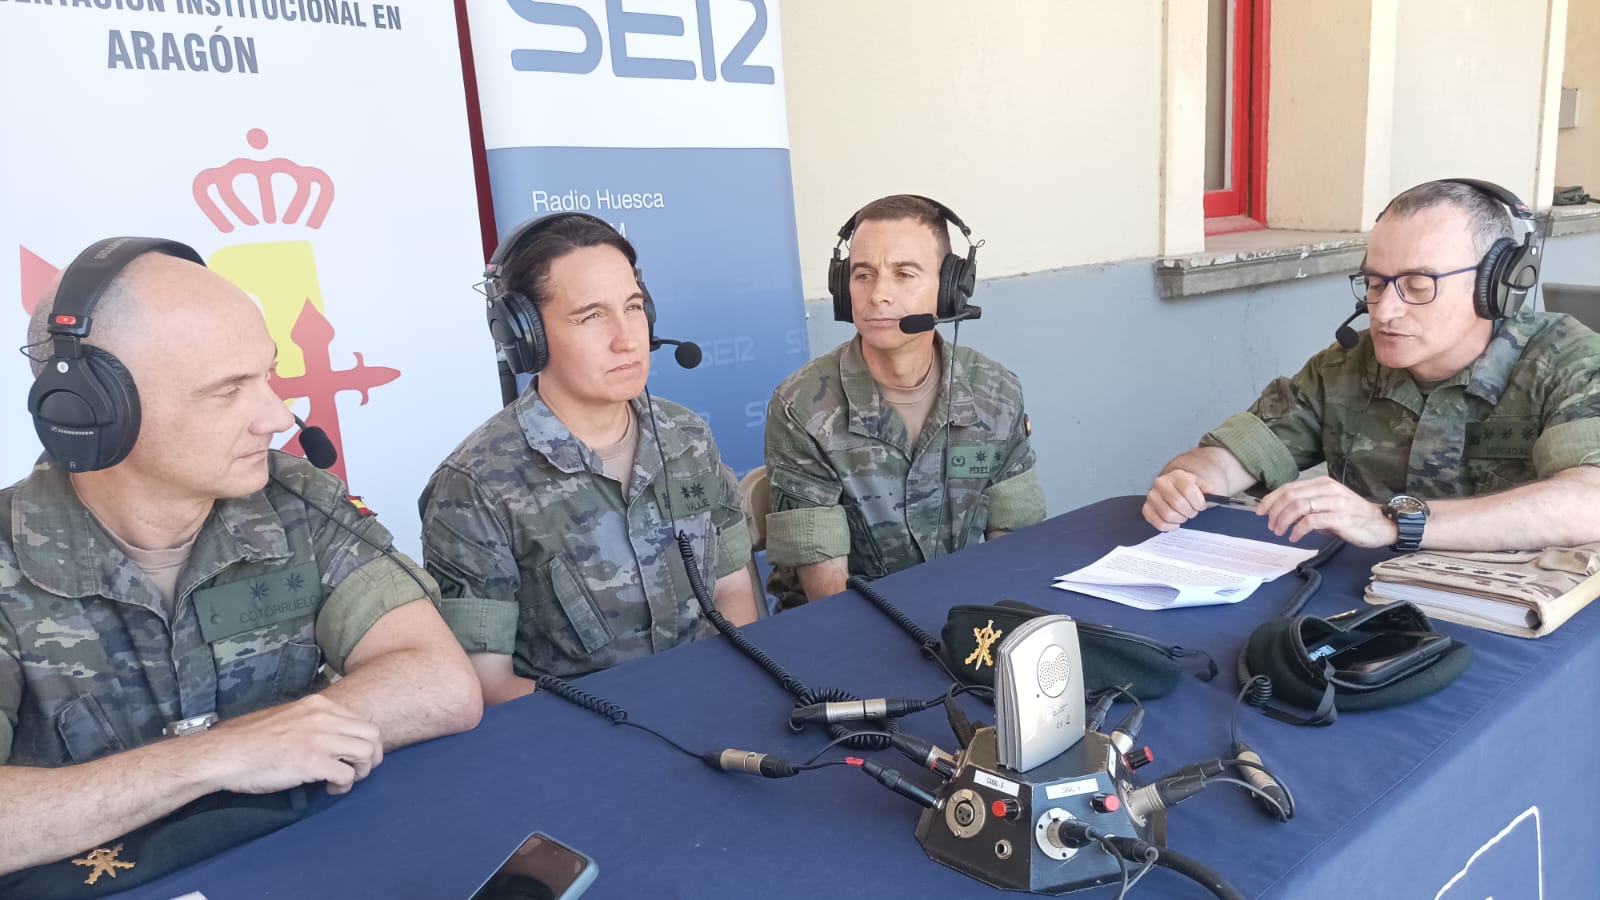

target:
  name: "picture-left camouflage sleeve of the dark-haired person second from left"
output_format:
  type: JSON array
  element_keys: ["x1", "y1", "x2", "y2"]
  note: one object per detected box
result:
[{"x1": 419, "y1": 466, "x2": 522, "y2": 655}]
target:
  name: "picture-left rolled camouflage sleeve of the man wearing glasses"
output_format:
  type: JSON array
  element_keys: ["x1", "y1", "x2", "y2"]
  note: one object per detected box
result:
[{"x1": 1200, "y1": 354, "x2": 1325, "y2": 490}]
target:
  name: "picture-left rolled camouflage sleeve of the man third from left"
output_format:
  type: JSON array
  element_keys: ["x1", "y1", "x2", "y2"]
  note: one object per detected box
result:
[{"x1": 766, "y1": 394, "x2": 850, "y2": 565}]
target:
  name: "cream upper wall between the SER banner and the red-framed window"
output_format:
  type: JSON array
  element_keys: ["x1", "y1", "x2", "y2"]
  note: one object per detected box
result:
[{"x1": 782, "y1": 0, "x2": 1164, "y2": 298}]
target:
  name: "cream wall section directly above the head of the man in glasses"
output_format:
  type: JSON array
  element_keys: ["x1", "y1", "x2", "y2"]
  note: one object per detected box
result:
[{"x1": 1388, "y1": 0, "x2": 1548, "y2": 199}]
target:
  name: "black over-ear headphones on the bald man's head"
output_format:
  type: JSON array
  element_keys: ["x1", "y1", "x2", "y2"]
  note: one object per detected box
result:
[{"x1": 27, "y1": 237, "x2": 205, "y2": 472}]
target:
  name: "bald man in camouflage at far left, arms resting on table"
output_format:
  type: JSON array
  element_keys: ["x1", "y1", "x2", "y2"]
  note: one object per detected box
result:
[{"x1": 0, "y1": 238, "x2": 482, "y2": 873}]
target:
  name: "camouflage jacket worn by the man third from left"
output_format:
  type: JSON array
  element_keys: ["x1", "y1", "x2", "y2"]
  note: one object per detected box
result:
[{"x1": 766, "y1": 329, "x2": 1045, "y2": 605}]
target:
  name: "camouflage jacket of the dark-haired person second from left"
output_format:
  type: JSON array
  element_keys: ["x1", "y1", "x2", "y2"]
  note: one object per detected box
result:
[{"x1": 418, "y1": 381, "x2": 750, "y2": 677}]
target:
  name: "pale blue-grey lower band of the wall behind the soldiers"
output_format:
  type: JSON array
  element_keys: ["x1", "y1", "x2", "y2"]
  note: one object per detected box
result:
[{"x1": 808, "y1": 234, "x2": 1600, "y2": 514}]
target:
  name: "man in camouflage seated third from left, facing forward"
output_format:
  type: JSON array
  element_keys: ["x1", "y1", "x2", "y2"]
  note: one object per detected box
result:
[{"x1": 766, "y1": 195, "x2": 1045, "y2": 607}]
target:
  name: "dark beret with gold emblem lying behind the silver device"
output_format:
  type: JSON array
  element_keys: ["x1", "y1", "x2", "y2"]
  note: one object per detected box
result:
[{"x1": 939, "y1": 601, "x2": 1216, "y2": 700}]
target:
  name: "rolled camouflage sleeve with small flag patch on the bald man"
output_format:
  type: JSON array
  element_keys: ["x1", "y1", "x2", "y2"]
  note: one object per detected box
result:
[{"x1": 286, "y1": 466, "x2": 435, "y2": 673}]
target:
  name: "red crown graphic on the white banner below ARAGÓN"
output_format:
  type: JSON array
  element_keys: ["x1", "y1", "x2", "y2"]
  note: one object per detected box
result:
[{"x1": 194, "y1": 128, "x2": 333, "y2": 234}]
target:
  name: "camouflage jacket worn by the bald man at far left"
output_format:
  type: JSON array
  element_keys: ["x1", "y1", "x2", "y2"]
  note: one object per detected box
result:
[{"x1": 0, "y1": 453, "x2": 426, "y2": 765}]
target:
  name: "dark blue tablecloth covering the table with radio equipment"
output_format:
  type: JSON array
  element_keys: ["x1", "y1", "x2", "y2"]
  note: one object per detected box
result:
[{"x1": 112, "y1": 498, "x2": 1600, "y2": 900}]
